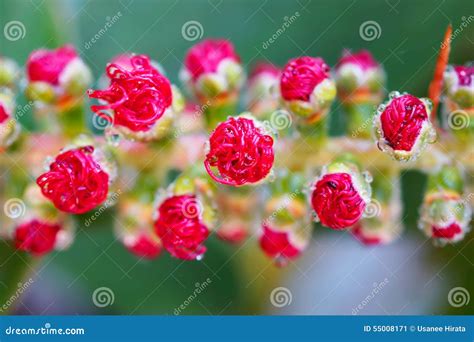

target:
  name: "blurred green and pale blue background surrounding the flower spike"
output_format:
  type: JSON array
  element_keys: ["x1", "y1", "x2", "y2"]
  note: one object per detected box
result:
[{"x1": 0, "y1": 0, "x2": 474, "y2": 315}]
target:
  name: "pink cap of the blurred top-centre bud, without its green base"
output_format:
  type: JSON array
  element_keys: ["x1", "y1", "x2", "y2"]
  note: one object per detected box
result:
[{"x1": 184, "y1": 39, "x2": 240, "y2": 81}]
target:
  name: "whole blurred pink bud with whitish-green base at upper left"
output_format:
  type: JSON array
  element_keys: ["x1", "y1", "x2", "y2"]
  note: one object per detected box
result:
[{"x1": 26, "y1": 45, "x2": 92, "y2": 104}]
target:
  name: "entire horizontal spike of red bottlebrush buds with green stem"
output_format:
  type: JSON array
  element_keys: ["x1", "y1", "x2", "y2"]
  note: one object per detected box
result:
[{"x1": 0, "y1": 34, "x2": 474, "y2": 266}]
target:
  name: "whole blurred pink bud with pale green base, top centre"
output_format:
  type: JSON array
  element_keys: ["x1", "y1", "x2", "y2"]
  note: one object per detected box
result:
[{"x1": 180, "y1": 39, "x2": 245, "y2": 103}]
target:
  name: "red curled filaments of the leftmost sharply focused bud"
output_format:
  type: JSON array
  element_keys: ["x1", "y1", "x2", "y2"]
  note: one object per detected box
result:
[{"x1": 36, "y1": 146, "x2": 109, "y2": 214}]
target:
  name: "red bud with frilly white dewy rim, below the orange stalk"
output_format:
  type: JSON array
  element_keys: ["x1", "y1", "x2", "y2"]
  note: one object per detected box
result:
[{"x1": 374, "y1": 92, "x2": 436, "y2": 161}]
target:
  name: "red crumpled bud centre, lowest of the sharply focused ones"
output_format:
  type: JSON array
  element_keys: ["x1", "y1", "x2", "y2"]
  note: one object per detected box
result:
[{"x1": 155, "y1": 195, "x2": 209, "y2": 260}]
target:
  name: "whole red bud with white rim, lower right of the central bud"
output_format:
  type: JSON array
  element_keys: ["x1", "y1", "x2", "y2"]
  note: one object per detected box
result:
[{"x1": 311, "y1": 160, "x2": 371, "y2": 229}]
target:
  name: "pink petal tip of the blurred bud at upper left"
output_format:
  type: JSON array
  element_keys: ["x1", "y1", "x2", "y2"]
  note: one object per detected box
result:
[{"x1": 26, "y1": 45, "x2": 78, "y2": 86}]
